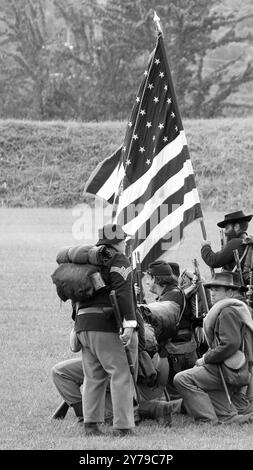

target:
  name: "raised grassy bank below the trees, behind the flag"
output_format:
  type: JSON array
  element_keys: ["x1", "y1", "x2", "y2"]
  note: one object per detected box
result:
[{"x1": 0, "y1": 118, "x2": 253, "y2": 212}]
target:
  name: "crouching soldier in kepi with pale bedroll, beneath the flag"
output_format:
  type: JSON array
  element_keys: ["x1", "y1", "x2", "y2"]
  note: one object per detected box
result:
[{"x1": 140, "y1": 261, "x2": 197, "y2": 397}]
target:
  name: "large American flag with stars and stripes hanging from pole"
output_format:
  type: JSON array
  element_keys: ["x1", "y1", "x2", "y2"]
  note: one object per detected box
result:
[{"x1": 85, "y1": 33, "x2": 202, "y2": 269}]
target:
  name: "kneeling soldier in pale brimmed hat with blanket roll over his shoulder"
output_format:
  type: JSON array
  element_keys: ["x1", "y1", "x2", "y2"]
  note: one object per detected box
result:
[{"x1": 174, "y1": 271, "x2": 253, "y2": 424}]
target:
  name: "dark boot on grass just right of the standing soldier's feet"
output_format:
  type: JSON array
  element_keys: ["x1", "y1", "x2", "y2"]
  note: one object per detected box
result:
[{"x1": 139, "y1": 400, "x2": 172, "y2": 426}]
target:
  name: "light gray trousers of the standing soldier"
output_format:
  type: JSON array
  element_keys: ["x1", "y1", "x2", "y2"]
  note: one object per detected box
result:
[{"x1": 78, "y1": 331, "x2": 138, "y2": 429}]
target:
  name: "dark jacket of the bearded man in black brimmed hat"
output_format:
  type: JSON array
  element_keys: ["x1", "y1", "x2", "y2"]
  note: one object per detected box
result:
[{"x1": 201, "y1": 238, "x2": 245, "y2": 271}]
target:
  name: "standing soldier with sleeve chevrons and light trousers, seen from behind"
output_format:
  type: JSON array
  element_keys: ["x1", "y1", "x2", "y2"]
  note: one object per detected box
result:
[{"x1": 75, "y1": 224, "x2": 138, "y2": 436}]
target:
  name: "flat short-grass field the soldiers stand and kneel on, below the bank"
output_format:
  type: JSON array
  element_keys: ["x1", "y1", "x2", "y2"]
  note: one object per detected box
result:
[{"x1": 0, "y1": 208, "x2": 253, "y2": 450}]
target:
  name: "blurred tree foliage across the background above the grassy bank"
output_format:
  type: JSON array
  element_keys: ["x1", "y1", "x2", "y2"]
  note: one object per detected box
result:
[{"x1": 0, "y1": 0, "x2": 253, "y2": 121}]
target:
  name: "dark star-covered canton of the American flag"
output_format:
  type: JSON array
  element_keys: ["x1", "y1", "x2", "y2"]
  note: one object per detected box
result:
[{"x1": 122, "y1": 35, "x2": 182, "y2": 188}]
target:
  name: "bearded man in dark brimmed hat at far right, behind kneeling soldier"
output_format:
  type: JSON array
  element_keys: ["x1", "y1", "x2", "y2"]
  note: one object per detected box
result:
[{"x1": 201, "y1": 211, "x2": 253, "y2": 283}]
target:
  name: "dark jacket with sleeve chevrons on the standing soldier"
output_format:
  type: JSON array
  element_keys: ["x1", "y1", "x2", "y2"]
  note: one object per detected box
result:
[{"x1": 75, "y1": 250, "x2": 136, "y2": 332}]
